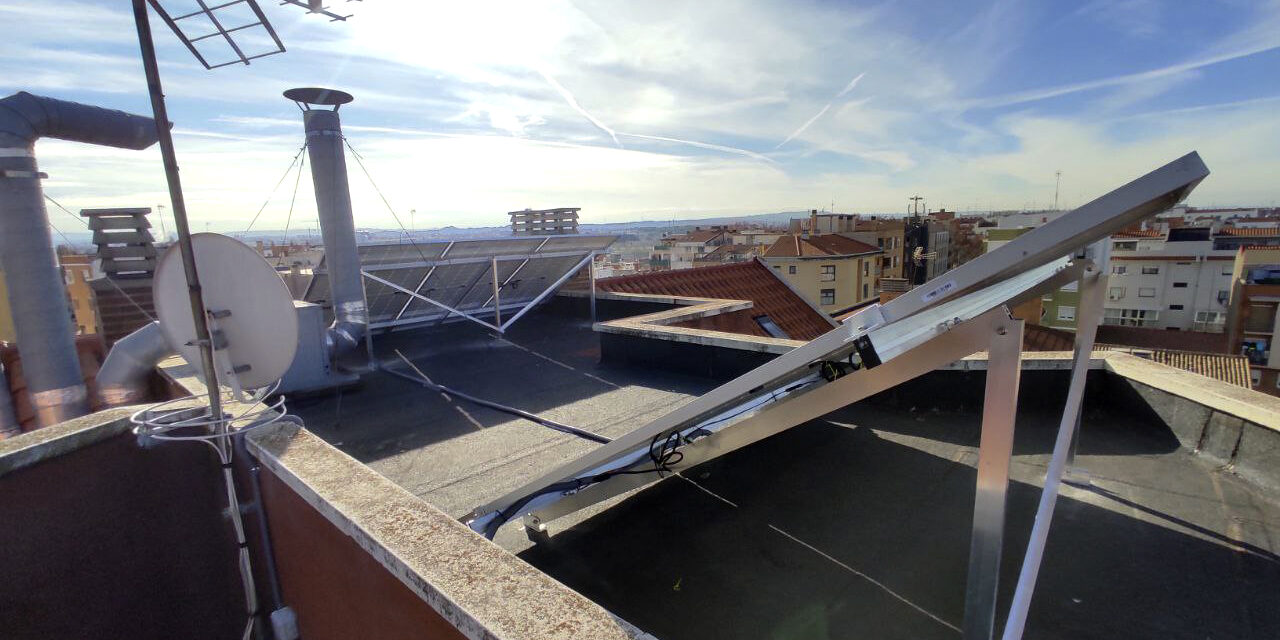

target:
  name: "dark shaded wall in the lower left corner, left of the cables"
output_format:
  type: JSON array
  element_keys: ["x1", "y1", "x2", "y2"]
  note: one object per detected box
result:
[{"x1": 0, "y1": 433, "x2": 246, "y2": 640}]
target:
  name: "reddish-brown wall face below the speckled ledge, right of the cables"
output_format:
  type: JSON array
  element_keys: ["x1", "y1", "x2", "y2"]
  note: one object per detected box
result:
[{"x1": 253, "y1": 468, "x2": 465, "y2": 640}]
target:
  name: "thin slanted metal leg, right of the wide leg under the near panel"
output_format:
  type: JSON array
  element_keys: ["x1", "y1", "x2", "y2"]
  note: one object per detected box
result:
[{"x1": 1004, "y1": 262, "x2": 1107, "y2": 640}]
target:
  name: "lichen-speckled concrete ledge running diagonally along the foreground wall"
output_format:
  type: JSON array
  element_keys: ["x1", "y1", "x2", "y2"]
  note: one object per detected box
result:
[{"x1": 248, "y1": 425, "x2": 652, "y2": 640}]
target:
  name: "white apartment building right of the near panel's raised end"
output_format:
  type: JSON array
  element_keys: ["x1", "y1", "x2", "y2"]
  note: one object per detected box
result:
[{"x1": 1102, "y1": 227, "x2": 1236, "y2": 333}]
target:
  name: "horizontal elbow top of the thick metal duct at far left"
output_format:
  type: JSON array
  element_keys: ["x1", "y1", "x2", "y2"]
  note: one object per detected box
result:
[{"x1": 0, "y1": 91, "x2": 157, "y2": 151}]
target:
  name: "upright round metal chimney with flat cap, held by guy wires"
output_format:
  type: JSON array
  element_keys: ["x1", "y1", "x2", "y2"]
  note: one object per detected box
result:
[{"x1": 284, "y1": 88, "x2": 369, "y2": 357}]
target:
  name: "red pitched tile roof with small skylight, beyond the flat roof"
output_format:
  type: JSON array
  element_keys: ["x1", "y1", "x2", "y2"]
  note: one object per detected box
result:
[{"x1": 595, "y1": 260, "x2": 832, "y2": 340}]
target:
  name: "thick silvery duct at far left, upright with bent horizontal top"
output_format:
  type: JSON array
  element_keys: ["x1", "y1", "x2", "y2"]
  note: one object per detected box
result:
[{"x1": 0, "y1": 92, "x2": 156, "y2": 426}]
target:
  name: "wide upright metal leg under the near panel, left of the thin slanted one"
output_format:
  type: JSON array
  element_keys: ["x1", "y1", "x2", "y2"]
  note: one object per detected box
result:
[{"x1": 964, "y1": 314, "x2": 1023, "y2": 640}]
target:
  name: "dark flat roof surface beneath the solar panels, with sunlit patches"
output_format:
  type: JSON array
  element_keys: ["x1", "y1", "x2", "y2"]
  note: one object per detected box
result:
[{"x1": 291, "y1": 302, "x2": 1280, "y2": 640}]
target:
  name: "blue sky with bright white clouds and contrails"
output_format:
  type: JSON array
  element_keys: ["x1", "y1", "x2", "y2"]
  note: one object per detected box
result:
[{"x1": 0, "y1": 0, "x2": 1280, "y2": 230}]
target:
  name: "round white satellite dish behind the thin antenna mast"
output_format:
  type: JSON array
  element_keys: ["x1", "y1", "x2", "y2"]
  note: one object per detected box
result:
[{"x1": 152, "y1": 233, "x2": 298, "y2": 393}]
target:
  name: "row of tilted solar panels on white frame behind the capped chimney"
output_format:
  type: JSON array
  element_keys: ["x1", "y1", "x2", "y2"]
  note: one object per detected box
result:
[{"x1": 303, "y1": 236, "x2": 617, "y2": 329}]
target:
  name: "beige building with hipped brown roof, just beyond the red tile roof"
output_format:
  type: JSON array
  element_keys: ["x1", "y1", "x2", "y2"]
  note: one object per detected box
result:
[{"x1": 763, "y1": 233, "x2": 884, "y2": 314}]
